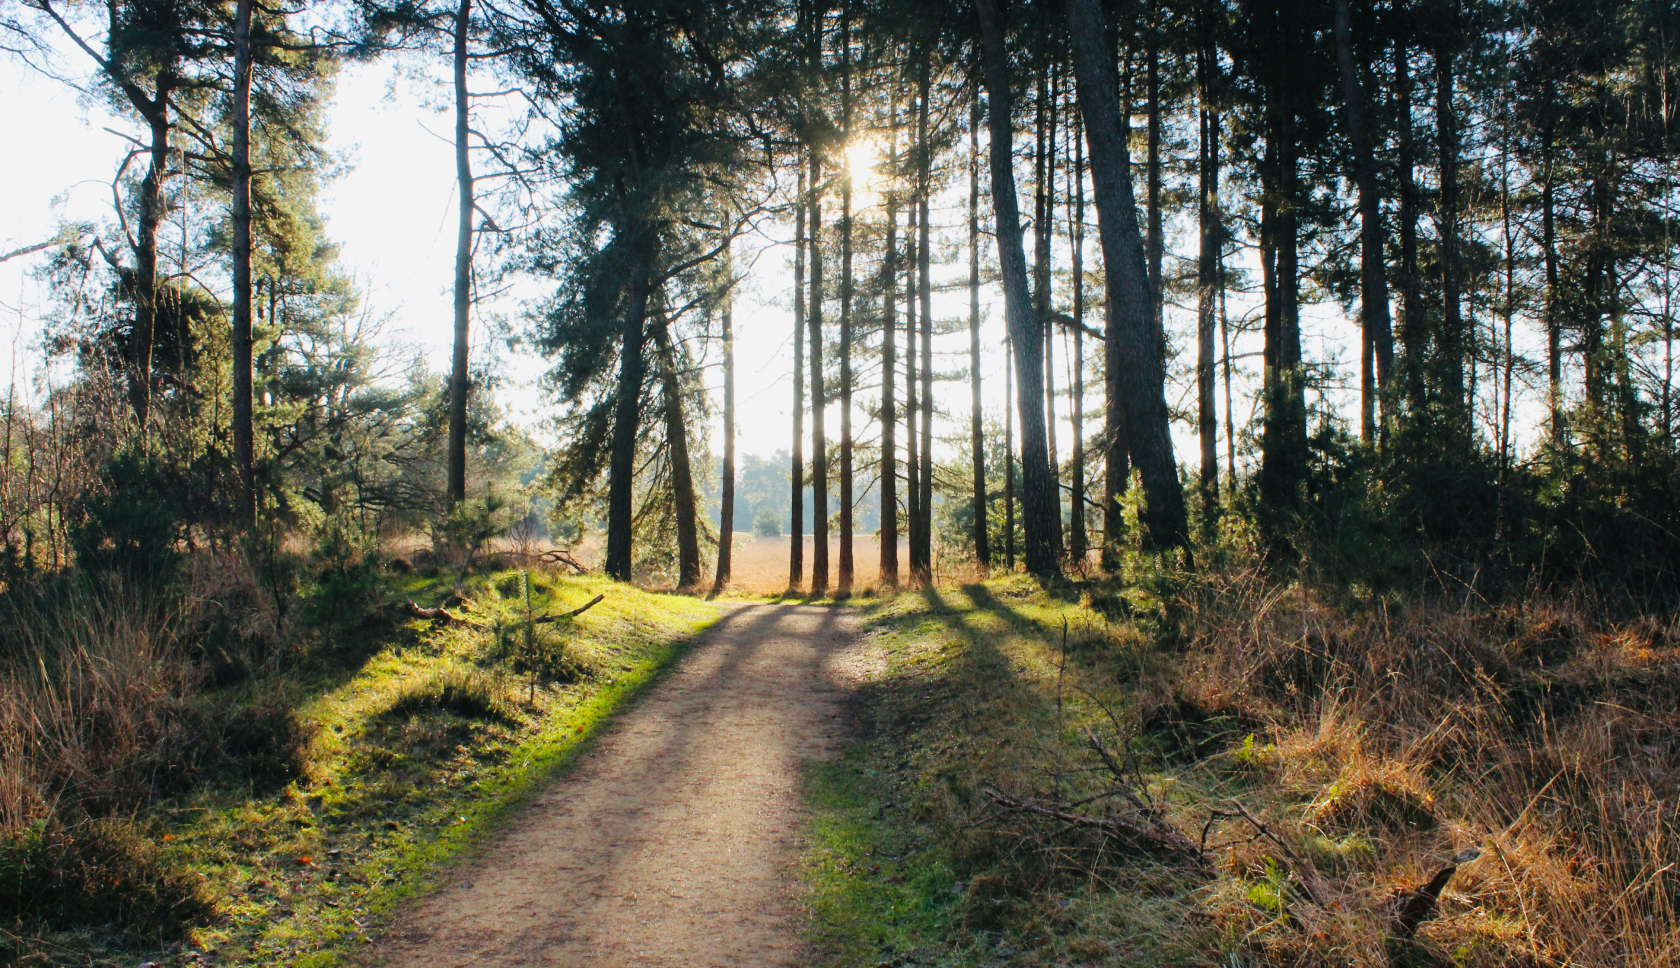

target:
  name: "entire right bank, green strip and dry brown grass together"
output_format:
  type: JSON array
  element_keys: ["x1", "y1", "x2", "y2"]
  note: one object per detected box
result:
[{"x1": 806, "y1": 573, "x2": 1680, "y2": 968}]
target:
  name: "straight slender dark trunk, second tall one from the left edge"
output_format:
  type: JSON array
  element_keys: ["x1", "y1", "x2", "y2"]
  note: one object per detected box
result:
[{"x1": 231, "y1": 0, "x2": 257, "y2": 529}]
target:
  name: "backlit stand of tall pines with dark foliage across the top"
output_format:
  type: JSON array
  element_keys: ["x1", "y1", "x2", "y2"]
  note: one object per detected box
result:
[{"x1": 0, "y1": 0, "x2": 1680, "y2": 595}]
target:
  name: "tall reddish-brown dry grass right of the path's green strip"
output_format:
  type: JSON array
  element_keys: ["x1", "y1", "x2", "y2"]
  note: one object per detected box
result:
[{"x1": 1179, "y1": 575, "x2": 1680, "y2": 966}]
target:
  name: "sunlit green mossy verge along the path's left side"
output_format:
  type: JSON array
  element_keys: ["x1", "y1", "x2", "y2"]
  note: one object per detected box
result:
[{"x1": 8, "y1": 571, "x2": 716, "y2": 966}]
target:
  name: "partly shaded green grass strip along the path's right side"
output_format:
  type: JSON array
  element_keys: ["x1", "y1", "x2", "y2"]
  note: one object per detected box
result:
[{"x1": 805, "y1": 580, "x2": 1198, "y2": 968}]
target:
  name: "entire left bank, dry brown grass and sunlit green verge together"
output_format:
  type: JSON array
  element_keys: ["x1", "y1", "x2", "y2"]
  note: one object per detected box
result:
[{"x1": 0, "y1": 556, "x2": 716, "y2": 966}]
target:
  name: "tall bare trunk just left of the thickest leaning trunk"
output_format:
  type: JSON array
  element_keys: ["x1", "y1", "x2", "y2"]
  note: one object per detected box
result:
[{"x1": 974, "y1": 0, "x2": 1055, "y2": 578}]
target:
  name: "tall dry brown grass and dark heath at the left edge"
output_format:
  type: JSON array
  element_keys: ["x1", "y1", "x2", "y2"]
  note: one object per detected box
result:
[{"x1": 0, "y1": 561, "x2": 307, "y2": 939}]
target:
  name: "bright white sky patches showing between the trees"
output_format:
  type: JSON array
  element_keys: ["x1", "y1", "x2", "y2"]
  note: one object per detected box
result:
[{"x1": 0, "y1": 40, "x2": 1552, "y2": 480}]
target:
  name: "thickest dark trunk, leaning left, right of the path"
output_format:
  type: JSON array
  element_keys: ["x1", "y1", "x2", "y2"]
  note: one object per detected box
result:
[{"x1": 1067, "y1": 0, "x2": 1189, "y2": 550}]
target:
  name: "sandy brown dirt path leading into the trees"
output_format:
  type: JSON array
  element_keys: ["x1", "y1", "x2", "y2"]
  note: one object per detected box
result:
[{"x1": 370, "y1": 605, "x2": 864, "y2": 968}]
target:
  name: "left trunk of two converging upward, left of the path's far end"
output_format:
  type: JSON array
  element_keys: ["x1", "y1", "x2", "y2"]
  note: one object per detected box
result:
[{"x1": 606, "y1": 233, "x2": 659, "y2": 581}]
